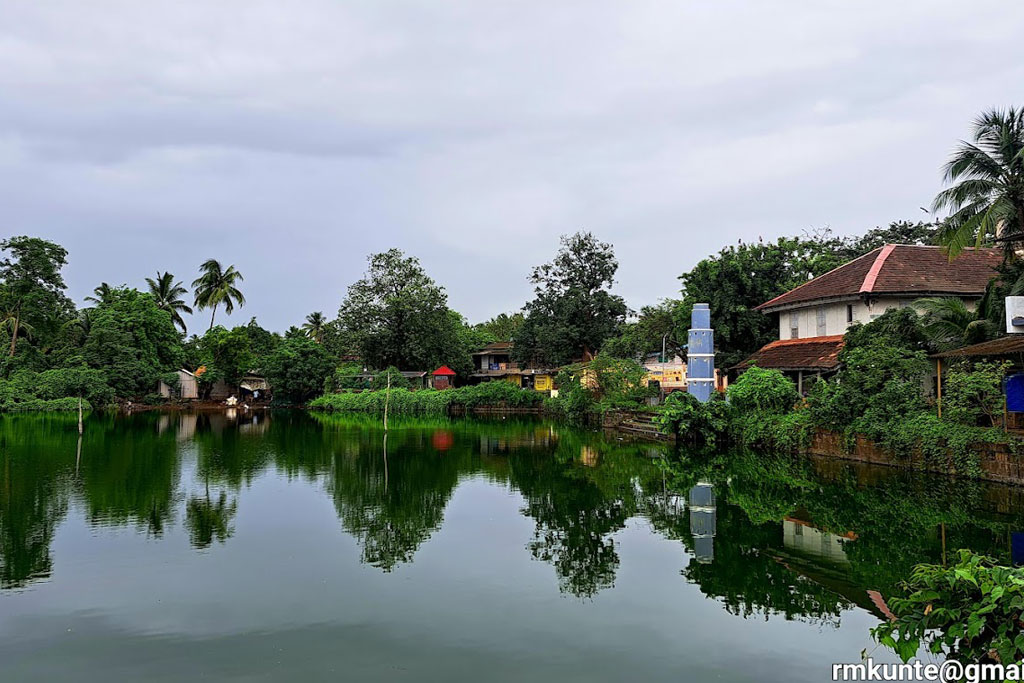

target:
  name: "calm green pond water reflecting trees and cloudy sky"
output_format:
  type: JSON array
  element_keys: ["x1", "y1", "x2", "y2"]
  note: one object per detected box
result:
[{"x1": 0, "y1": 412, "x2": 1024, "y2": 682}]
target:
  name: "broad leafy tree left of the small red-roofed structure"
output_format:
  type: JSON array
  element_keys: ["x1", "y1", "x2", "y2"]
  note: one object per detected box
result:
[{"x1": 332, "y1": 249, "x2": 469, "y2": 370}]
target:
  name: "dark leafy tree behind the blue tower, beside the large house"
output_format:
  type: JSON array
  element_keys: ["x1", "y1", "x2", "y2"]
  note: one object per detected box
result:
[{"x1": 675, "y1": 234, "x2": 847, "y2": 368}]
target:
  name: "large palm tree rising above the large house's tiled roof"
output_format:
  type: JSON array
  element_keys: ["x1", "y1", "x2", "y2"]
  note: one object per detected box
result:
[{"x1": 932, "y1": 108, "x2": 1024, "y2": 259}]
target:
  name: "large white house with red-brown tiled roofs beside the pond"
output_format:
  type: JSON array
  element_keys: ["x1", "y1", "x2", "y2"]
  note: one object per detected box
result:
[{"x1": 733, "y1": 245, "x2": 1002, "y2": 392}]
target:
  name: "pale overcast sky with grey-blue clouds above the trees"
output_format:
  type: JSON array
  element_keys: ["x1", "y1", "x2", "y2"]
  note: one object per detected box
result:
[{"x1": 0, "y1": 0, "x2": 1024, "y2": 331}]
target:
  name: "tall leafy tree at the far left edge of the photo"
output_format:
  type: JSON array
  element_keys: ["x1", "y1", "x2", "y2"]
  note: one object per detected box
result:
[{"x1": 0, "y1": 236, "x2": 74, "y2": 357}]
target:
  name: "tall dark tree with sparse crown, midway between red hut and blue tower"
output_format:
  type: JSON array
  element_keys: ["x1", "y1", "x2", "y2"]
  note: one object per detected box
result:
[{"x1": 513, "y1": 232, "x2": 629, "y2": 366}]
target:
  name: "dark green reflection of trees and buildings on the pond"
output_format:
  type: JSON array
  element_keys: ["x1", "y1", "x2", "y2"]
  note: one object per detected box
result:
[{"x1": 0, "y1": 411, "x2": 1024, "y2": 625}]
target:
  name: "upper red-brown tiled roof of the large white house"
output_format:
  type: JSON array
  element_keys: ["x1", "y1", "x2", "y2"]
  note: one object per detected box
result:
[{"x1": 757, "y1": 245, "x2": 1002, "y2": 312}]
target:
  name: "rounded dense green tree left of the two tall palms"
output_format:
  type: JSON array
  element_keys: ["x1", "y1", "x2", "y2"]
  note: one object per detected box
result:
[{"x1": 82, "y1": 288, "x2": 182, "y2": 397}]
